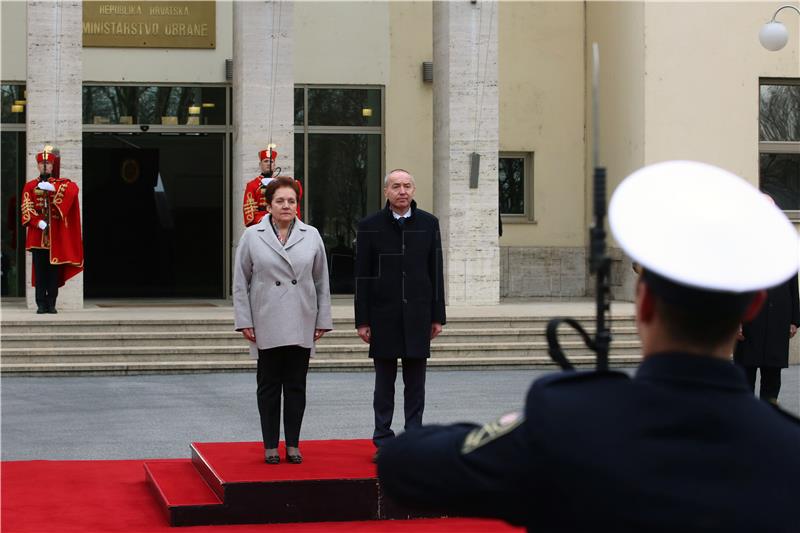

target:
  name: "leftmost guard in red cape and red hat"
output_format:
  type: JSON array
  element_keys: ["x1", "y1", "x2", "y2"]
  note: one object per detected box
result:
[{"x1": 20, "y1": 146, "x2": 83, "y2": 314}]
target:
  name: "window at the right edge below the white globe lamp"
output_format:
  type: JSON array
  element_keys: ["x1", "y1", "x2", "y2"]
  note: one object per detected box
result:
[{"x1": 758, "y1": 79, "x2": 800, "y2": 216}]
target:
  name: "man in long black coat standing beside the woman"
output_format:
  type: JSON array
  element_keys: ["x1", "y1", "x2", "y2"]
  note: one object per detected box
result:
[{"x1": 355, "y1": 169, "x2": 445, "y2": 448}]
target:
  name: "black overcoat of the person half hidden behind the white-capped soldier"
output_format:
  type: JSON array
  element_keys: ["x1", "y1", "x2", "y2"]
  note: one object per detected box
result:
[{"x1": 733, "y1": 276, "x2": 800, "y2": 368}]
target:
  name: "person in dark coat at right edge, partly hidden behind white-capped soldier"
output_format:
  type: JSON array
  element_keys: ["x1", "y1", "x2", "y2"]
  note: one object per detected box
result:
[{"x1": 733, "y1": 276, "x2": 800, "y2": 402}]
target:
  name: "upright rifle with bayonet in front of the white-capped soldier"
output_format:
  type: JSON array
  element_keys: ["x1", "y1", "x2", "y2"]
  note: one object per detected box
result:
[{"x1": 547, "y1": 43, "x2": 611, "y2": 372}]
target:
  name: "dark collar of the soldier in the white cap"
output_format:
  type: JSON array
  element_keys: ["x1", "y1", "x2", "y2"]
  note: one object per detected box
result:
[{"x1": 636, "y1": 352, "x2": 749, "y2": 392}]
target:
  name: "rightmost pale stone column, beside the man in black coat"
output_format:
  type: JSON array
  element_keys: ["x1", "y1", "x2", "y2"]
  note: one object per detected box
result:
[{"x1": 433, "y1": 0, "x2": 500, "y2": 305}]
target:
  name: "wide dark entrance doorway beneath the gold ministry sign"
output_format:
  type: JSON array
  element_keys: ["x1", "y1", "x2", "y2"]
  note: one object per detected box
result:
[{"x1": 83, "y1": 133, "x2": 225, "y2": 298}]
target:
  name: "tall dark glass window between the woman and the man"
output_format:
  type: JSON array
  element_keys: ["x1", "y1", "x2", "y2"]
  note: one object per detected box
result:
[{"x1": 294, "y1": 85, "x2": 384, "y2": 294}]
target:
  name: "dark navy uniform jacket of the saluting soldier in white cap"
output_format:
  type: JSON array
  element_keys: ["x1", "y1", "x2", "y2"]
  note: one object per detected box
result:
[{"x1": 378, "y1": 353, "x2": 800, "y2": 533}]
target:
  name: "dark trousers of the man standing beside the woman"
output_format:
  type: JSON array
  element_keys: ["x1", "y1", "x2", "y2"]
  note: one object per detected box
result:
[{"x1": 372, "y1": 357, "x2": 428, "y2": 447}]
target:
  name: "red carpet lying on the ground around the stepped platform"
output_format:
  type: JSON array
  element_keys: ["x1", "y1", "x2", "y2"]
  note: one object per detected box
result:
[{"x1": 0, "y1": 458, "x2": 522, "y2": 533}]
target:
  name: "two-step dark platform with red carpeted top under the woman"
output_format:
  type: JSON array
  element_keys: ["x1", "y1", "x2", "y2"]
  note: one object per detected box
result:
[{"x1": 144, "y1": 440, "x2": 442, "y2": 526}]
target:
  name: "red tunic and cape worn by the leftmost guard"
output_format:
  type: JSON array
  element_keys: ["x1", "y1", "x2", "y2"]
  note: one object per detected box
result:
[{"x1": 20, "y1": 178, "x2": 83, "y2": 286}]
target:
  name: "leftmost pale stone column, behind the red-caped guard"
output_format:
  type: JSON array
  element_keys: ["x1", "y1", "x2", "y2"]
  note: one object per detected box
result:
[{"x1": 25, "y1": 0, "x2": 83, "y2": 309}]
